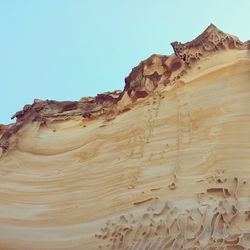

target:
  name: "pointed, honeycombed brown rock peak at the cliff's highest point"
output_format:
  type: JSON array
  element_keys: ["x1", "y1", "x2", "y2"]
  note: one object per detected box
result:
[{"x1": 171, "y1": 24, "x2": 243, "y2": 65}]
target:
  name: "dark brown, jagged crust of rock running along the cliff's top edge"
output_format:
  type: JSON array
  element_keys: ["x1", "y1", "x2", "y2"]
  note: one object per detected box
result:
[{"x1": 0, "y1": 24, "x2": 249, "y2": 152}]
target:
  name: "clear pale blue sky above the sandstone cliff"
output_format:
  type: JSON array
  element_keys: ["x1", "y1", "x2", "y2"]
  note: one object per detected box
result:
[{"x1": 0, "y1": 0, "x2": 250, "y2": 124}]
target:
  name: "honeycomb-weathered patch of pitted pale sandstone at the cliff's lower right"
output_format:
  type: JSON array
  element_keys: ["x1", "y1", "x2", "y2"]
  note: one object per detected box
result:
[{"x1": 95, "y1": 179, "x2": 250, "y2": 249}]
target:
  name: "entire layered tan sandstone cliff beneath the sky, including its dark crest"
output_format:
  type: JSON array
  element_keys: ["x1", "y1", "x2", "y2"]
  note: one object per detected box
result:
[{"x1": 0, "y1": 25, "x2": 250, "y2": 250}]
